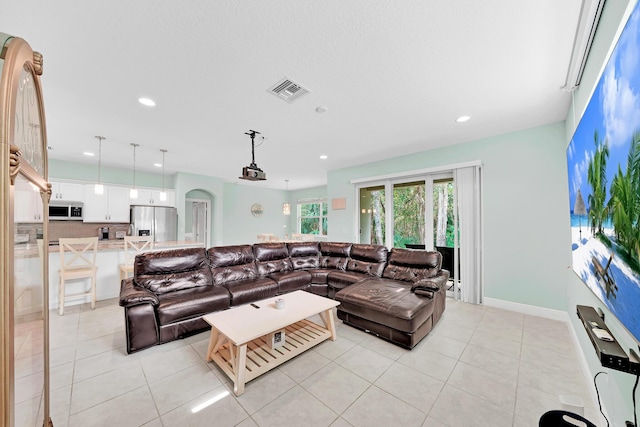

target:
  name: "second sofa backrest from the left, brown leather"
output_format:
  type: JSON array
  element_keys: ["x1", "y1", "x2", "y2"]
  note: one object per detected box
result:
[{"x1": 208, "y1": 245, "x2": 258, "y2": 286}]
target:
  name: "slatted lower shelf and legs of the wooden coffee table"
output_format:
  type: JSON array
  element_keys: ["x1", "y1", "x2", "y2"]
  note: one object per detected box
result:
[{"x1": 207, "y1": 320, "x2": 332, "y2": 395}]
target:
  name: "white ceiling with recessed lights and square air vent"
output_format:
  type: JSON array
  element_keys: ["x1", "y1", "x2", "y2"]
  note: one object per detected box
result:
[{"x1": 0, "y1": 0, "x2": 582, "y2": 190}]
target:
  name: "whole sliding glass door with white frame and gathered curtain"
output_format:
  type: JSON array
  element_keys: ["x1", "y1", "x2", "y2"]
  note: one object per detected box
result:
[{"x1": 357, "y1": 169, "x2": 482, "y2": 303}]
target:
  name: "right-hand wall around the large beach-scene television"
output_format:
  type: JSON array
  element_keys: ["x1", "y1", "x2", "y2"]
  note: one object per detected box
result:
[{"x1": 563, "y1": 0, "x2": 638, "y2": 426}]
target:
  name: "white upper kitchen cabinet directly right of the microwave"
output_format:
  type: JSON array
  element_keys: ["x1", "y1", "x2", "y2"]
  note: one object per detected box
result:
[{"x1": 83, "y1": 184, "x2": 129, "y2": 222}]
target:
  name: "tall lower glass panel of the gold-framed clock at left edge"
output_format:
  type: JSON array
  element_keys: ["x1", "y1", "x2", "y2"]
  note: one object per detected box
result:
[{"x1": 13, "y1": 174, "x2": 45, "y2": 426}]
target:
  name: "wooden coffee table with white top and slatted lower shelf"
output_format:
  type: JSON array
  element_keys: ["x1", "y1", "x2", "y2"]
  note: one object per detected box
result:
[{"x1": 203, "y1": 291, "x2": 340, "y2": 396}]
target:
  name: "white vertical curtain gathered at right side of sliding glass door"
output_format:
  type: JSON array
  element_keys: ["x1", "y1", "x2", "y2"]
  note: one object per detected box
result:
[{"x1": 453, "y1": 166, "x2": 482, "y2": 304}]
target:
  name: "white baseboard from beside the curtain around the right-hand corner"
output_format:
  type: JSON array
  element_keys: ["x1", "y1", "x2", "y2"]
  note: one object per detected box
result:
[{"x1": 483, "y1": 298, "x2": 598, "y2": 411}]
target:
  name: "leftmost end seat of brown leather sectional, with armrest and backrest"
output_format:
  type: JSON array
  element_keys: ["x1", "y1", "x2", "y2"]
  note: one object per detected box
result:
[{"x1": 120, "y1": 248, "x2": 230, "y2": 353}]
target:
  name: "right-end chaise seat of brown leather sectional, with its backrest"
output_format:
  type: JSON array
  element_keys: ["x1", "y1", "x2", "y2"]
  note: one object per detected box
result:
[{"x1": 335, "y1": 248, "x2": 449, "y2": 349}]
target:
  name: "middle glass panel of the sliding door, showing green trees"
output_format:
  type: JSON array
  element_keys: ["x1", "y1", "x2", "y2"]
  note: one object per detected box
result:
[{"x1": 393, "y1": 181, "x2": 426, "y2": 248}]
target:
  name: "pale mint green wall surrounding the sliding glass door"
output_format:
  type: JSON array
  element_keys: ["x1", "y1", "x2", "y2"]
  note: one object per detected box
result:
[{"x1": 328, "y1": 123, "x2": 570, "y2": 310}]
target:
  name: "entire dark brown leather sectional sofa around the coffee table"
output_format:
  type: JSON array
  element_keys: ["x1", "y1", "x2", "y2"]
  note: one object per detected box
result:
[{"x1": 120, "y1": 242, "x2": 449, "y2": 353}]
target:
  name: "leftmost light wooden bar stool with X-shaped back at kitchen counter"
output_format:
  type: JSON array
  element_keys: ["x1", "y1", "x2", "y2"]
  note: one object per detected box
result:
[{"x1": 58, "y1": 237, "x2": 98, "y2": 316}]
